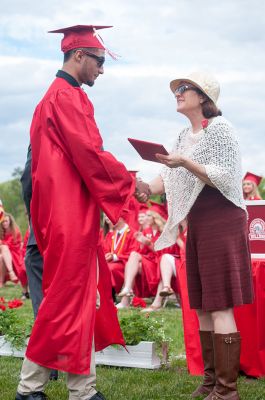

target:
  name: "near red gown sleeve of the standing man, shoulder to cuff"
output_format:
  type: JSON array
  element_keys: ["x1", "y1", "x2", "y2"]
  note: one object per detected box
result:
[{"x1": 47, "y1": 88, "x2": 135, "y2": 223}]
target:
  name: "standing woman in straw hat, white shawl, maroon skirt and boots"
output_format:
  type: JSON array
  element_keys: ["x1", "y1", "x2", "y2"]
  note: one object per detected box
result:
[{"x1": 140, "y1": 72, "x2": 253, "y2": 400}]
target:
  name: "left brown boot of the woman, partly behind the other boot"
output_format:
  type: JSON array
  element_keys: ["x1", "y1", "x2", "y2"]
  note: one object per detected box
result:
[{"x1": 191, "y1": 331, "x2": 215, "y2": 398}]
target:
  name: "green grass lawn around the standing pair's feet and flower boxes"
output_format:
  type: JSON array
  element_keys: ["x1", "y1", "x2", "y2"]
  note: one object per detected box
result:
[{"x1": 0, "y1": 284, "x2": 265, "y2": 400}]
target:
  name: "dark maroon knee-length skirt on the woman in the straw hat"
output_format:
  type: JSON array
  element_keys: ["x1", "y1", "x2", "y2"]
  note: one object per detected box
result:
[{"x1": 186, "y1": 185, "x2": 253, "y2": 311}]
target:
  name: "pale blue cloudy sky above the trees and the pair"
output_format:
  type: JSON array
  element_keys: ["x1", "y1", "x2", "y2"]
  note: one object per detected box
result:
[{"x1": 0, "y1": 0, "x2": 265, "y2": 182}]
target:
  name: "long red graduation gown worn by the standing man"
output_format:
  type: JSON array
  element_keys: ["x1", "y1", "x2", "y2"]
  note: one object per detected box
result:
[{"x1": 26, "y1": 78, "x2": 134, "y2": 374}]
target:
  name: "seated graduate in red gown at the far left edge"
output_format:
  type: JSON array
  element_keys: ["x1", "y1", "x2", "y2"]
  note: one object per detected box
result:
[{"x1": 0, "y1": 213, "x2": 28, "y2": 296}]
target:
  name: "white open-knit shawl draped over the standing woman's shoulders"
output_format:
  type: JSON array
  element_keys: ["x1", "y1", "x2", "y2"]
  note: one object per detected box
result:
[{"x1": 155, "y1": 117, "x2": 246, "y2": 250}]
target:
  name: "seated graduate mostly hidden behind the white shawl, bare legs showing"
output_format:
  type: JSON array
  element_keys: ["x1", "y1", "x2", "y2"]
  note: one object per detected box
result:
[{"x1": 142, "y1": 220, "x2": 187, "y2": 312}]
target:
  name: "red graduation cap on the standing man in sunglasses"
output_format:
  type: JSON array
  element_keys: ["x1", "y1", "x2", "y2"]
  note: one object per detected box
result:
[{"x1": 49, "y1": 25, "x2": 112, "y2": 53}]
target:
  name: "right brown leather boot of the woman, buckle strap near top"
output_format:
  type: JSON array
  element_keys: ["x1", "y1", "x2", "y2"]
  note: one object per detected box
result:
[{"x1": 205, "y1": 332, "x2": 241, "y2": 400}]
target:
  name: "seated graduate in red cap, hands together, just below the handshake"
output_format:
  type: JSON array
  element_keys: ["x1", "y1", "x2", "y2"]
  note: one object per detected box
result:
[{"x1": 117, "y1": 202, "x2": 167, "y2": 308}]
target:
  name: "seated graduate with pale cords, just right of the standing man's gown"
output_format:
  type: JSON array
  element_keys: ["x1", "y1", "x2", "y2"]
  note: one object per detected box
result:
[{"x1": 102, "y1": 218, "x2": 136, "y2": 293}]
